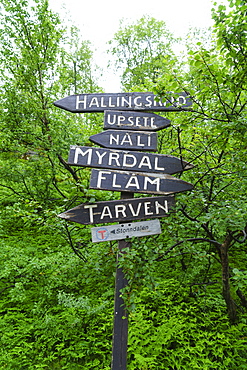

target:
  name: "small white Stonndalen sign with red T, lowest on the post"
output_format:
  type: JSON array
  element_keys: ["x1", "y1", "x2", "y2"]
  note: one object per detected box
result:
[{"x1": 91, "y1": 220, "x2": 161, "y2": 243}]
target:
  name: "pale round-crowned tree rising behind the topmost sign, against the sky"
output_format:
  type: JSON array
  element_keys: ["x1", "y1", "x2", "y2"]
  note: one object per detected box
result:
[{"x1": 109, "y1": 16, "x2": 177, "y2": 91}]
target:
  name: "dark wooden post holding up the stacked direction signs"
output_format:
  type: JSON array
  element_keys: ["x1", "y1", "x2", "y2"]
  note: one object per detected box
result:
[{"x1": 111, "y1": 192, "x2": 134, "y2": 370}]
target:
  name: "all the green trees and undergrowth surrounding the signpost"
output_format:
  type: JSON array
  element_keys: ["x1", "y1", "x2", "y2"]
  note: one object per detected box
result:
[{"x1": 0, "y1": 0, "x2": 247, "y2": 370}]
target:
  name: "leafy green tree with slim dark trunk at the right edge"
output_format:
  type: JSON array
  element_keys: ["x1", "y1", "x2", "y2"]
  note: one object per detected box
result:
[{"x1": 167, "y1": 1, "x2": 247, "y2": 322}]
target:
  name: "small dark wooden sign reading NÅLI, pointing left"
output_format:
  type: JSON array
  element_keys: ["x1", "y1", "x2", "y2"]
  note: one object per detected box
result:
[{"x1": 89, "y1": 130, "x2": 157, "y2": 151}]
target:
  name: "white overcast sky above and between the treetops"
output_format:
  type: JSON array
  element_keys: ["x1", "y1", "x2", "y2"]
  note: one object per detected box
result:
[{"x1": 50, "y1": 0, "x2": 228, "y2": 92}]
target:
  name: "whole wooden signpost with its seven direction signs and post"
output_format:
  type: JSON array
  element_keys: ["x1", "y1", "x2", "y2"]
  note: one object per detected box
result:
[{"x1": 54, "y1": 88, "x2": 193, "y2": 370}]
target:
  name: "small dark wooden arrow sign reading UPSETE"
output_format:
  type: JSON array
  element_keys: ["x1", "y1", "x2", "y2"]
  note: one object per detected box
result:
[{"x1": 104, "y1": 110, "x2": 171, "y2": 131}]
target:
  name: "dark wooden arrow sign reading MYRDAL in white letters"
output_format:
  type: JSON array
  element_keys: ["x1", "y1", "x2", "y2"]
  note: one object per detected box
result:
[{"x1": 68, "y1": 145, "x2": 193, "y2": 174}]
